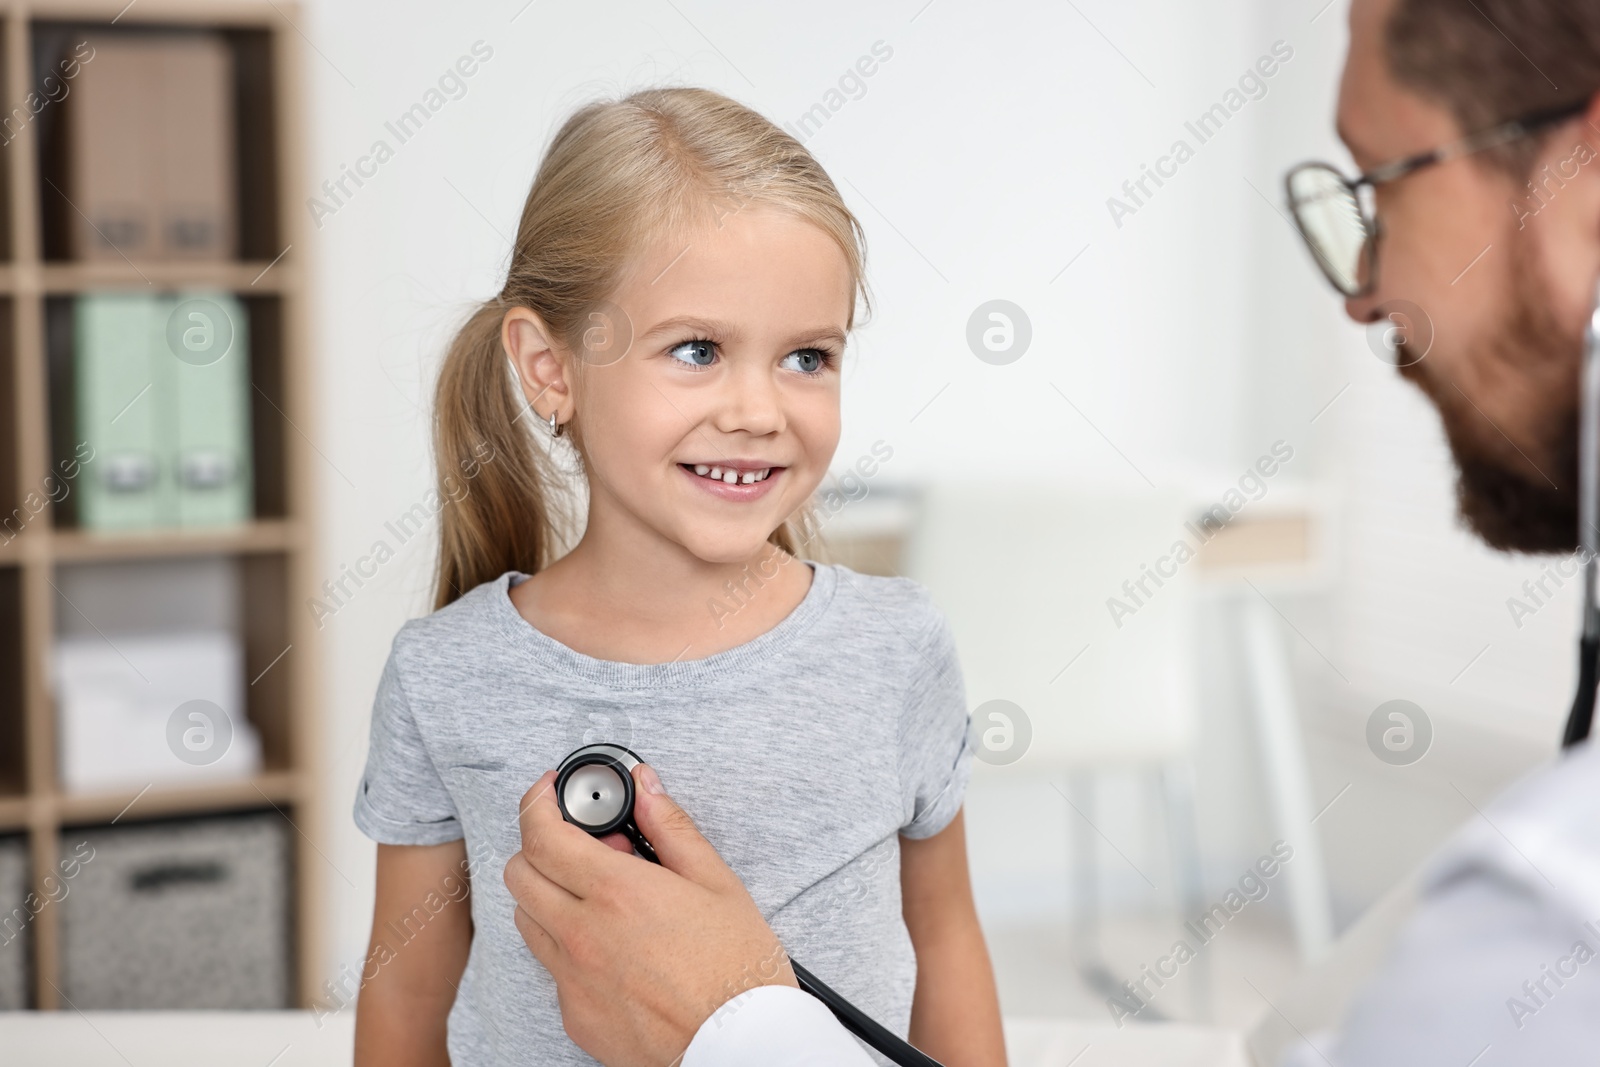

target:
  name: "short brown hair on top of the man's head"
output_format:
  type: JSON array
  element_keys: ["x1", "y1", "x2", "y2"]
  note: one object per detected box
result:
[{"x1": 1384, "y1": 0, "x2": 1600, "y2": 170}]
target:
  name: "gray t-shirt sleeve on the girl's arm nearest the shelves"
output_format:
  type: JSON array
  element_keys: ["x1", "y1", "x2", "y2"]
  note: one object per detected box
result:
[{"x1": 355, "y1": 653, "x2": 462, "y2": 845}]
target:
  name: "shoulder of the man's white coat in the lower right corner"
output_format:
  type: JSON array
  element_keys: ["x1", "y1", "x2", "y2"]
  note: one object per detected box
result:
[{"x1": 1283, "y1": 742, "x2": 1600, "y2": 1067}]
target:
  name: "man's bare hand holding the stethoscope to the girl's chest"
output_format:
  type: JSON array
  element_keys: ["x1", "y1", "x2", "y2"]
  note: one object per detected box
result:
[{"x1": 506, "y1": 765, "x2": 795, "y2": 1067}]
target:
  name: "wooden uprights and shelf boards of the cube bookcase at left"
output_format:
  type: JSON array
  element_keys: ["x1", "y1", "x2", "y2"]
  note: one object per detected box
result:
[{"x1": 0, "y1": 0, "x2": 326, "y2": 1009}]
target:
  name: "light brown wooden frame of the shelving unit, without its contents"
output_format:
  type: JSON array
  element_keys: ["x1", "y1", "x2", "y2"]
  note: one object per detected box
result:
[{"x1": 0, "y1": 0, "x2": 326, "y2": 1009}]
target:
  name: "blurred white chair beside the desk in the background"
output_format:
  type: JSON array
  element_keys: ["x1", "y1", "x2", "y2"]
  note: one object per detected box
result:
[{"x1": 904, "y1": 483, "x2": 1210, "y2": 1019}]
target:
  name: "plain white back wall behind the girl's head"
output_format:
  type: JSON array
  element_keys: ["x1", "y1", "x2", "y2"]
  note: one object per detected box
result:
[{"x1": 288, "y1": 0, "x2": 1288, "y2": 979}]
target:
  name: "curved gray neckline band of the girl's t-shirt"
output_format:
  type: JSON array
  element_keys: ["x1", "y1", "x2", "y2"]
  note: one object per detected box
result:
[{"x1": 490, "y1": 560, "x2": 838, "y2": 688}]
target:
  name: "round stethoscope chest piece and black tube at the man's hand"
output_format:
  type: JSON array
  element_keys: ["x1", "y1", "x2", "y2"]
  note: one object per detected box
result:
[{"x1": 555, "y1": 744, "x2": 942, "y2": 1067}]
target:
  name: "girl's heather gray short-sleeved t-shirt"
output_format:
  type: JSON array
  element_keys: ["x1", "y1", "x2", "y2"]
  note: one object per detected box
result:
[{"x1": 355, "y1": 563, "x2": 971, "y2": 1065}]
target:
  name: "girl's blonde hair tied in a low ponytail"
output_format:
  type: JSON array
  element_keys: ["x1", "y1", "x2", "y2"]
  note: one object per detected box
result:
[{"x1": 434, "y1": 88, "x2": 869, "y2": 608}]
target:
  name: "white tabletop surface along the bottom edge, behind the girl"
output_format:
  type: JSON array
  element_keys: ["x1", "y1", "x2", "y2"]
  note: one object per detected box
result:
[{"x1": 0, "y1": 1009, "x2": 1250, "y2": 1067}]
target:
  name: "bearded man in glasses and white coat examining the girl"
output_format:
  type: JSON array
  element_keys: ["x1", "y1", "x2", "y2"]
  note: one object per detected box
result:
[{"x1": 506, "y1": 0, "x2": 1600, "y2": 1067}]
